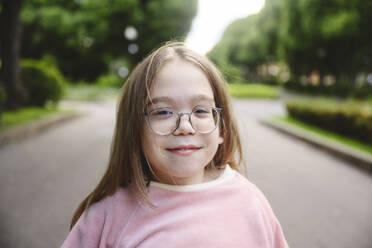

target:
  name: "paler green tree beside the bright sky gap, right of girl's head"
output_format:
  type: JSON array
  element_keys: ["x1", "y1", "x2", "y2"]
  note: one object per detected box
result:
[{"x1": 208, "y1": 0, "x2": 279, "y2": 83}]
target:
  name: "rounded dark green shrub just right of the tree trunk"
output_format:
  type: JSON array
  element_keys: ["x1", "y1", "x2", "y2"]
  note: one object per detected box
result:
[{"x1": 21, "y1": 59, "x2": 64, "y2": 106}]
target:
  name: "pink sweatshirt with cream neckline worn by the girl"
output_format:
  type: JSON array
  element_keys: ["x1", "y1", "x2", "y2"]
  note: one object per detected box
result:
[{"x1": 62, "y1": 166, "x2": 288, "y2": 248}]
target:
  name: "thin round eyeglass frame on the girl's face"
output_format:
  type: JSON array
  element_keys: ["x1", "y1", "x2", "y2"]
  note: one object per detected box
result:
[{"x1": 143, "y1": 106, "x2": 222, "y2": 136}]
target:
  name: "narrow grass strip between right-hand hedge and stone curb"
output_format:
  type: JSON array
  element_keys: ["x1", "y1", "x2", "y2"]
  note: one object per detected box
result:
[{"x1": 273, "y1": 116, "x2": 372, "y2": 154}]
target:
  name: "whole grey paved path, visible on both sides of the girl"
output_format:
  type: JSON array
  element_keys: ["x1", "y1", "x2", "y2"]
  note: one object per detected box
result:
[{"x1": 0, "y1": 100, "x2": 372, "y2": 248}]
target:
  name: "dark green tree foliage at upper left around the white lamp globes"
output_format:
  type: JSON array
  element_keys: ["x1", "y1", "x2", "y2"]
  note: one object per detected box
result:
[{"x1": 21, "y1": 0, "x2": 197, "y2": 80}]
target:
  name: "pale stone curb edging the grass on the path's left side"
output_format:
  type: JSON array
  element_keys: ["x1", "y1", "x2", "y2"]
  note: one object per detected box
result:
[{"x1": 0, "y1": 112, "x2": 87, "y2": 147}]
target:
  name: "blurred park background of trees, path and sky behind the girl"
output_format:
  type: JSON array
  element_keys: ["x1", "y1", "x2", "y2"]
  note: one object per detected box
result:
[{"x1": 0, "y1": 0, "x2": 372, "y2": 248}]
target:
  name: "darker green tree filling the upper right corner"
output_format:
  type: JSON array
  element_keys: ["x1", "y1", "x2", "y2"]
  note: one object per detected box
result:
[{"x1": 278, "y1": 0, "x2": 372, "y2": 84}]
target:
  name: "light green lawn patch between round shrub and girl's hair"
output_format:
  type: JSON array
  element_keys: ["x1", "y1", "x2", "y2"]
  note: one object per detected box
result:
[{"x1": 64, "y1": 84, "x2": 120, "y2": 101}]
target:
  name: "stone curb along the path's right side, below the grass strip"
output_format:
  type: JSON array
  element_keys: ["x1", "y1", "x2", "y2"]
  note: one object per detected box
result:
[{"x1": 259, "y1": 119, "x2": 372, "y2": 173}]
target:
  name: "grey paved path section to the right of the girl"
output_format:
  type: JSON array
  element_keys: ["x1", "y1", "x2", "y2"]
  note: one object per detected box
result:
[{"x1": 235, "y1": 100, "x2": 372, "y2": 248}]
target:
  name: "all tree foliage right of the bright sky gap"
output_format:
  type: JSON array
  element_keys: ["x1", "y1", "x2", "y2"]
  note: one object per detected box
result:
[{"x1": 209, "y1": 0, "x2": 372, "y2": 93}]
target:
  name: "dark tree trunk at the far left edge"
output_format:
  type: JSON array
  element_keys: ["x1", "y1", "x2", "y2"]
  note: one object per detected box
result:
[{"x1": 0, "y1": 0, "x2": 27, "y2": 109}]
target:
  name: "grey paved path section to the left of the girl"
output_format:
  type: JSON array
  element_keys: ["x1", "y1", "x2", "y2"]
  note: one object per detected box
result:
[{"x1": 0, "y1": 103, "x2": 115, "y2": 248}]
